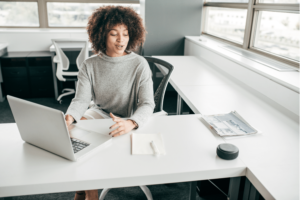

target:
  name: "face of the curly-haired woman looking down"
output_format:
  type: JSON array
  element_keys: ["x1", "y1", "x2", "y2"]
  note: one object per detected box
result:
[{"x1": 106, "y1": 24, "x2": 129, "y2": 57}]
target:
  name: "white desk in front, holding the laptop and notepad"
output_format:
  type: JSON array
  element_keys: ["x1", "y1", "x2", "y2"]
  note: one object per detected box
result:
[{"x1": 0, "y1": 115, "x2": 246, "y2": 197}]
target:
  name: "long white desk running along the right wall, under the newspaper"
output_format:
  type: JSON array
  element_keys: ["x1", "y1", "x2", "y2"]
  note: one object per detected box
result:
[{"x1": 157, "y1": 56, "x2": 300, "y2": 199}]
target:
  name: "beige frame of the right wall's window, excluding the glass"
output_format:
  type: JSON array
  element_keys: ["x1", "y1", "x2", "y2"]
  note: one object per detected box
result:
[{"x1": 201, "y1": 0, "x2": 300, "y2": 68}]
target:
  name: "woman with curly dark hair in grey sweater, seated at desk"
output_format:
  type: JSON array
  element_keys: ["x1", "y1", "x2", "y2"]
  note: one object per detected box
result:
[{"x1": 65, "y1": 6, "x2": 155, "y2": 200}]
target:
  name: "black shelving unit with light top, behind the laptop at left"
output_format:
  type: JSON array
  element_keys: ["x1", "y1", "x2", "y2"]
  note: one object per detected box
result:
[{"x1": 0, "y1": 52, "x2": 54, "y2": 98}]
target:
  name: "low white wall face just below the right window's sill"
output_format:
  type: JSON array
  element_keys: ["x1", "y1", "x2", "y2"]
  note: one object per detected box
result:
[{"x1": 184, "y1": 39, "x2": 300, "y2": 117}]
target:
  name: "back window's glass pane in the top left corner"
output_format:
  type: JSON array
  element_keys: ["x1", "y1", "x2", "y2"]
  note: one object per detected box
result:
[{"x1": 0, "y1": 1, "x2": 40, "y2": 27}]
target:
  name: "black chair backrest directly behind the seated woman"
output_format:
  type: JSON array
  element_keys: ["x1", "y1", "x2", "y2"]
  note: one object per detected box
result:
[{"x1": 144, "y1": 56, "x2": 174, "y2": 112}]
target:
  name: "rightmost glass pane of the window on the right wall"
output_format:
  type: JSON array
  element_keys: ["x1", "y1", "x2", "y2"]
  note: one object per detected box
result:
[{"x1": 254, "y1": 11, "x2": 300, "y2": 62}]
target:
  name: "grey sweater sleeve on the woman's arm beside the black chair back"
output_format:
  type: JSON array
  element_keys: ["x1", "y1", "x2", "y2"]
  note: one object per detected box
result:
[{"x1": 129, "y1": 60, "x2": 155, "y2": 128}]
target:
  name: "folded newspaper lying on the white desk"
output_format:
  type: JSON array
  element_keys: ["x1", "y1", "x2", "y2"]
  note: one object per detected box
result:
[{"x1": 202, "y1": 111, "x2": 258, "y2": 136}]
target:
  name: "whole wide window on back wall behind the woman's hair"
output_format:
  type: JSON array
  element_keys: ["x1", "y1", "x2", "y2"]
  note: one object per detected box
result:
[{"x1": 0, "y1": 0, "x2": 143, "y2": 28}]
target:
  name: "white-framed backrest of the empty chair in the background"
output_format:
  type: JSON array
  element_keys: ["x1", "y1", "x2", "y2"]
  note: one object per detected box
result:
[{"x1": 52, "y1": 38, "x2": 89, "y2": 70}]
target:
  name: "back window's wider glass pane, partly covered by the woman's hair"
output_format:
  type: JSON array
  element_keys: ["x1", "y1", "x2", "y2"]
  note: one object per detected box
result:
[{"x1": 47, "y1": 2, "x2": 140, "y2": 27}]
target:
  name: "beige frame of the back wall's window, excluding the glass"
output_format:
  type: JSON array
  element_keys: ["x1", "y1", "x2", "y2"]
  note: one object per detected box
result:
[{"x1": 0, "y1": 0, "x2": 144, "y2": 29}]
